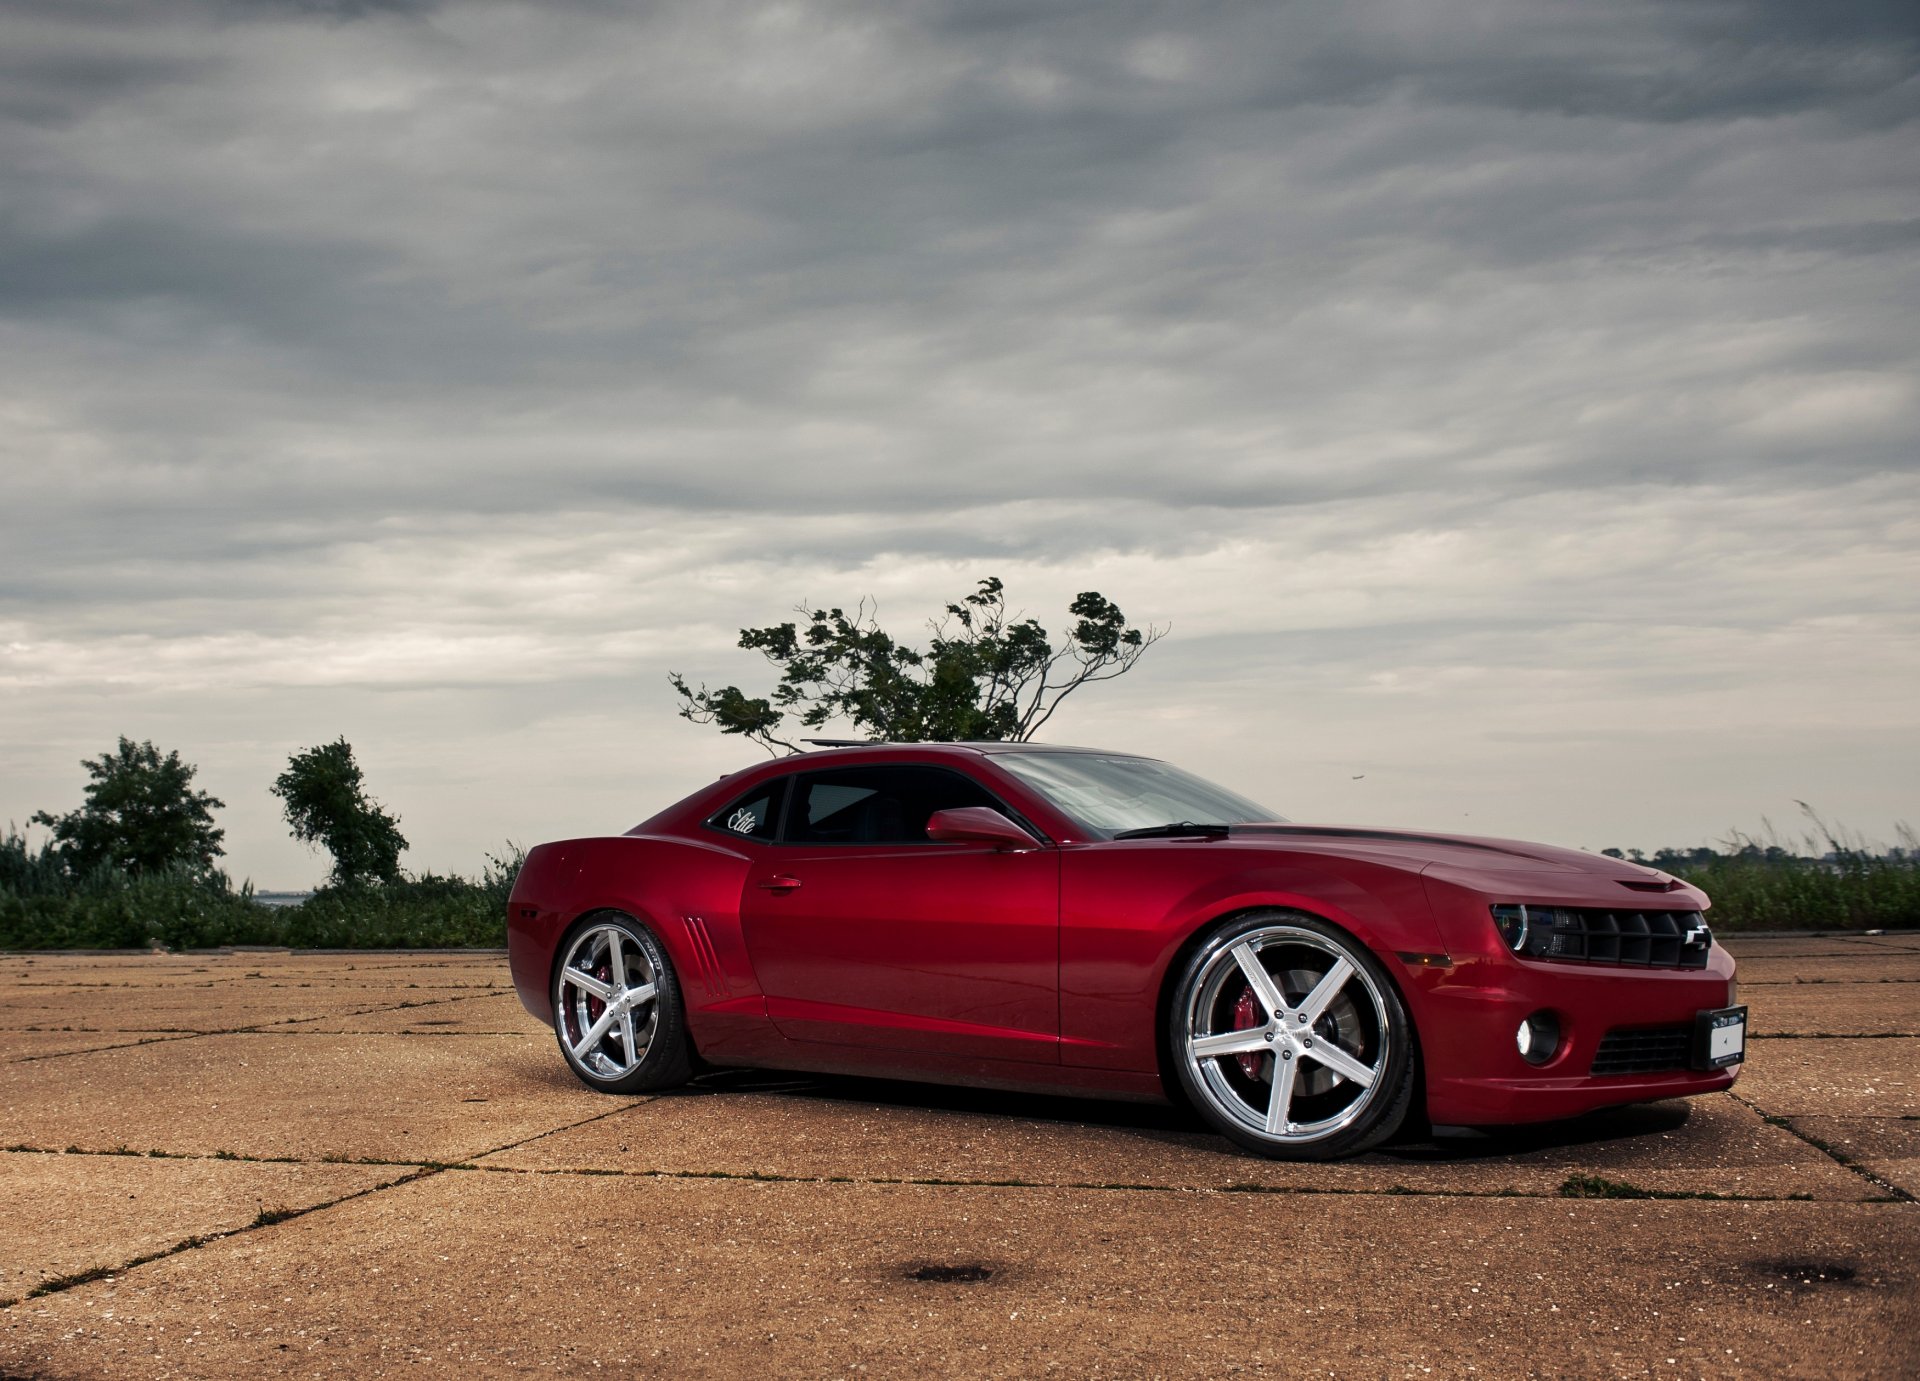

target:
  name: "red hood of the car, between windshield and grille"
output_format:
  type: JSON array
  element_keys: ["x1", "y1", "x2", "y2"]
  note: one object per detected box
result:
[{"x1": 1231, "y1": 824, "x2": 1688, "y2": 901}]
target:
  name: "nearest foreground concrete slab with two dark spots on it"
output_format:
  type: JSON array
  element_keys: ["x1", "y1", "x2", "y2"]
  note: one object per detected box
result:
[{"x1": 0, "y1": 1172, "x2": 1920, "y2": 1377}]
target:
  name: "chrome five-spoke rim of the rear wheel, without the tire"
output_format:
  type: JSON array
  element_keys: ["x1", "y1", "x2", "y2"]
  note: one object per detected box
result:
[{"x1": 553, "y1": 922, "x2": 660, "y2": 1083}]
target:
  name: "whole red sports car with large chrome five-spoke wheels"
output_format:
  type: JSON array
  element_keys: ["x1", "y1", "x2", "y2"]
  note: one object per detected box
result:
[{"x1": 507, "y1": 743, "x2": 1745, "y2": 1158}]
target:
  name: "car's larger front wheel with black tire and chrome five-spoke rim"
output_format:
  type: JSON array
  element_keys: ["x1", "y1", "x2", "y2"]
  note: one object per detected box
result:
[{"x1": 1167, "y1": 910, "x2": 1415, "y2": 1160}]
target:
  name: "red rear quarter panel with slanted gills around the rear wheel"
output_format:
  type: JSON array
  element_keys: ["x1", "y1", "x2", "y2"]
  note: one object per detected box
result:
[{"x1": 507, "y1": 836, "x2": 785, "y2": 1062}]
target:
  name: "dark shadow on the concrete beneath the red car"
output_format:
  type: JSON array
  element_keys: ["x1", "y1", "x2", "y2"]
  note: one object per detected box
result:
[{"x1": 664, "y1": 1070, "x2": 1690, "y2": 1164}]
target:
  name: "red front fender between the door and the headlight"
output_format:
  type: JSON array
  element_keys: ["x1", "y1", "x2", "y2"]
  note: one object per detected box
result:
[{"x1": 1060, "y1": 839, "x2": 1442, "y2": 1072}]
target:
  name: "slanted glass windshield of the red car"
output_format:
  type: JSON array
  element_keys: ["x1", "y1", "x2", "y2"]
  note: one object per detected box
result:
[{"x1": 993, "y1": 753, "x2": 1286, "y2": 834}]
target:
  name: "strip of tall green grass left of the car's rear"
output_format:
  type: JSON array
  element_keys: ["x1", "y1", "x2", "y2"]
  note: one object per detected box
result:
[{"x1": 0, "y1": 828, "x2": 520, "y2": 949}]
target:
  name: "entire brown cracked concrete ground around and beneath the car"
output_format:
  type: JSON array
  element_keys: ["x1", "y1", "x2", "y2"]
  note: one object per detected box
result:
[{"x1": 0, "y1": 935, "x2": 1920, "y2": 1377}]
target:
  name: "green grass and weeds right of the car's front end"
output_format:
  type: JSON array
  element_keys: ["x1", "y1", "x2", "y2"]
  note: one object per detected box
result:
[{"x1": 1605, "y1": 803, "x2": 1920, "y2": 932}]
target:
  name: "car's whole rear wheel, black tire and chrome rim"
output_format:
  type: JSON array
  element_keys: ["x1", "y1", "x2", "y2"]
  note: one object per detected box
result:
[{"x1": 553, "y1": 914, "x2": 693, "y2": 1093}]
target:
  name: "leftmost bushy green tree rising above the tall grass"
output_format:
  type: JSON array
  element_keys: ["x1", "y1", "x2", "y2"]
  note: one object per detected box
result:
[{"x1": 33, "y1": 738, "x2": 227, "y2": 878}]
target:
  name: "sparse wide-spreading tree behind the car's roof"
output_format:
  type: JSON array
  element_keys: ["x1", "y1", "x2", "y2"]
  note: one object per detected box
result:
[{"x1": 668, "y1": 578, "x2": 1165, "y2": 751}]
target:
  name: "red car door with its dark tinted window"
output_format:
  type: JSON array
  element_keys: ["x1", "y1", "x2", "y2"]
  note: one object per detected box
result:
[{"x1": 741, "y1": 764, "x2": 1060, "y2": 1064}]
